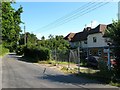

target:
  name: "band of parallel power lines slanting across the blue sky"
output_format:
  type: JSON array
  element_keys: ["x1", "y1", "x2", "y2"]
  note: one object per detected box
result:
[{"x1": 33, "y1": 2, "x2": 109, "y2": 32}]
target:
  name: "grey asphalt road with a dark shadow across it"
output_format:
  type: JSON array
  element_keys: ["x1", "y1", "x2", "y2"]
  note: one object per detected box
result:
[{"x1": 0, "y1": 54, "x2": 119, "y2": 90}]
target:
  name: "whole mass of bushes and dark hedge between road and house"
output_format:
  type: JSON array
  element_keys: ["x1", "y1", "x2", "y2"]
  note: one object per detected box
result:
[{"x1": 16, "y1": 32, "x2": 69, "y2": 62}]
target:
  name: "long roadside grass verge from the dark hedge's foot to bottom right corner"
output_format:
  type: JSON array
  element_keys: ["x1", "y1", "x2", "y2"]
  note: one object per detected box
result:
[{"x1": 39, "y1": 60, "x2": 120, "y2": 87}]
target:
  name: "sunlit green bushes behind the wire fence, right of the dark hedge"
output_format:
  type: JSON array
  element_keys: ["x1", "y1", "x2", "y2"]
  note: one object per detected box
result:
[{"x1": 37, "y1": 35, "x2": 69, "y2": 61}]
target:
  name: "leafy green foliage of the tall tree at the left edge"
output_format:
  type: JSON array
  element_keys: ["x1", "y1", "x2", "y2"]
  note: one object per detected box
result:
[{"x1": 2, "y1": 2, "x2": 23, "y2": 51}]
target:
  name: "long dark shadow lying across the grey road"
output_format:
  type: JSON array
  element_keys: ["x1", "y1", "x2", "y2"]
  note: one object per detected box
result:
[{"x1": 37, "y1": 74, "x2": 101, "y2": 85}]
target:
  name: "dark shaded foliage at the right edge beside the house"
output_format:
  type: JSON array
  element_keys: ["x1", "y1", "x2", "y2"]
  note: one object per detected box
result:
[{"x1": 105, "y1": 20, "x2": 120, "y2": 76}]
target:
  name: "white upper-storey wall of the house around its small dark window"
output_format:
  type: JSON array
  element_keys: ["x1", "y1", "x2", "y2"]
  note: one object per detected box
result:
[{"x1": 87, "y1": 33, "x2": 107, "y2": 47}]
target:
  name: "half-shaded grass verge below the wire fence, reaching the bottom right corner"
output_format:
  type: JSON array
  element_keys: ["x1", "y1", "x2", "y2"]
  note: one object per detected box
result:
[{"x1": 61, "y1": 64, "x2": 120, "y2": 87}]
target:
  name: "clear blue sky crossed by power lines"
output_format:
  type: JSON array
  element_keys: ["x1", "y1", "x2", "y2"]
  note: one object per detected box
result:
[{"x1": 12, "y1": 2, "x2": 118, "y2": 39}]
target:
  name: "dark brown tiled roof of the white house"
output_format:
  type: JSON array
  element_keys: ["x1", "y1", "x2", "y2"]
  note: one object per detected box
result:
[{"x1": 64, "y1": 24, "x2": 111, "y2": 42}]
